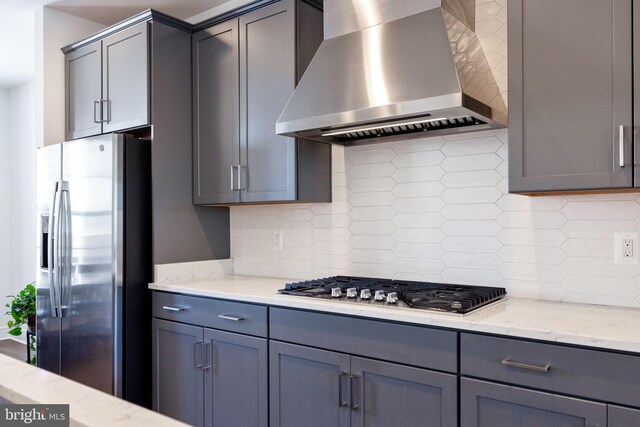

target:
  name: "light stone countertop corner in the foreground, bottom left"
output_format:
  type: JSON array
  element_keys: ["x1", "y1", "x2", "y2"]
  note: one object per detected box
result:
[{"x1": 0, "y1": 354, "x2": 186, "y2": 427}]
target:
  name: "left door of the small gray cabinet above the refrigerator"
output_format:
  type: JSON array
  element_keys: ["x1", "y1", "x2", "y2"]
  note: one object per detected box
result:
[{"x1": 64, "y1": 41, "x2": 102, "y2": 140}]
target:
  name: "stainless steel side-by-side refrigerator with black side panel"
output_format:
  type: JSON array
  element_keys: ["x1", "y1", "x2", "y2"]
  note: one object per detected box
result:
[{"x1": 36, "y1": 134, "x2": 152, "y2": 406}]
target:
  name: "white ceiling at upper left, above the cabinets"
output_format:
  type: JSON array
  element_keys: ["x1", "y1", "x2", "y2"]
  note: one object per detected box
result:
[{"x1": 0, "y1": 0, "x2": 230, "y2": 89}]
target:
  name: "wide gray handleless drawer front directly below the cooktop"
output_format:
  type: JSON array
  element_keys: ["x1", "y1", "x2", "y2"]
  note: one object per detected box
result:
[{"x1": 269, "y1": 307, "x2": 458, "y2": 372}]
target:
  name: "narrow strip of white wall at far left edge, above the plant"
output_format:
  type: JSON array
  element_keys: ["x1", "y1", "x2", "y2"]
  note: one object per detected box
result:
[{"x1": 0, "y1": 89, "x2": 12, "y2": 314}]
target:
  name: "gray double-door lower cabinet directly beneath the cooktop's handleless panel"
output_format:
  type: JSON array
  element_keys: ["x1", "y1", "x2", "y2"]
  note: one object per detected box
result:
[{"x1": 269, "y1": 341, "x2": 458, "y2": 427}]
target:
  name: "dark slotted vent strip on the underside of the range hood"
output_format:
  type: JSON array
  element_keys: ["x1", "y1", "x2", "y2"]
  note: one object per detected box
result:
[{"x1": 320, "y1": 116, "x2": 485, "y2": 142}]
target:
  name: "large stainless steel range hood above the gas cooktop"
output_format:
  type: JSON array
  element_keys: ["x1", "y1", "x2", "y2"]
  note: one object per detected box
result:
[{"x1": 276, "y1": 0, "x2": 507, "y2": 144}]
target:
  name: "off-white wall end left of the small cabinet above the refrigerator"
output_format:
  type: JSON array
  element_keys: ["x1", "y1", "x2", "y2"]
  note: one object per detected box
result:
[{"x1": 36, "y1": 7, "x2": 105, "y2": 145}]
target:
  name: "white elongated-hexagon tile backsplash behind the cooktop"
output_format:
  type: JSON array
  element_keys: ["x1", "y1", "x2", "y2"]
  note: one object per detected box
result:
[{"x1": 231, "y1": 130, "x2": 640, "y2": 307}]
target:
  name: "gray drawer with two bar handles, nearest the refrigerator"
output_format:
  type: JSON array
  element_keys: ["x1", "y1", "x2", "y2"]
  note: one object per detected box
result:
[{"x1": 153, "y1": 292, "x2": 267, "y2": 337}]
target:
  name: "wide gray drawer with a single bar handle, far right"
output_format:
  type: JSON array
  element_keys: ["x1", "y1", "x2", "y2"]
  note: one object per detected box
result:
[{"x1": 460, "y1": 333, "x2": 640, "y2": 406}]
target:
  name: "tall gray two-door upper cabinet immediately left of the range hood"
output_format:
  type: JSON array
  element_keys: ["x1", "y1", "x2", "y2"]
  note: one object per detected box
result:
[{"x1": 192, "y1": 0, "x2": 331, "y2": 205}]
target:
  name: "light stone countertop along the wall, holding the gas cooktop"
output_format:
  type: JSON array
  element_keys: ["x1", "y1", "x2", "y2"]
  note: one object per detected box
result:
[{"x1": 149, "y1": 275, "x2": 640, "y2": 353}]
